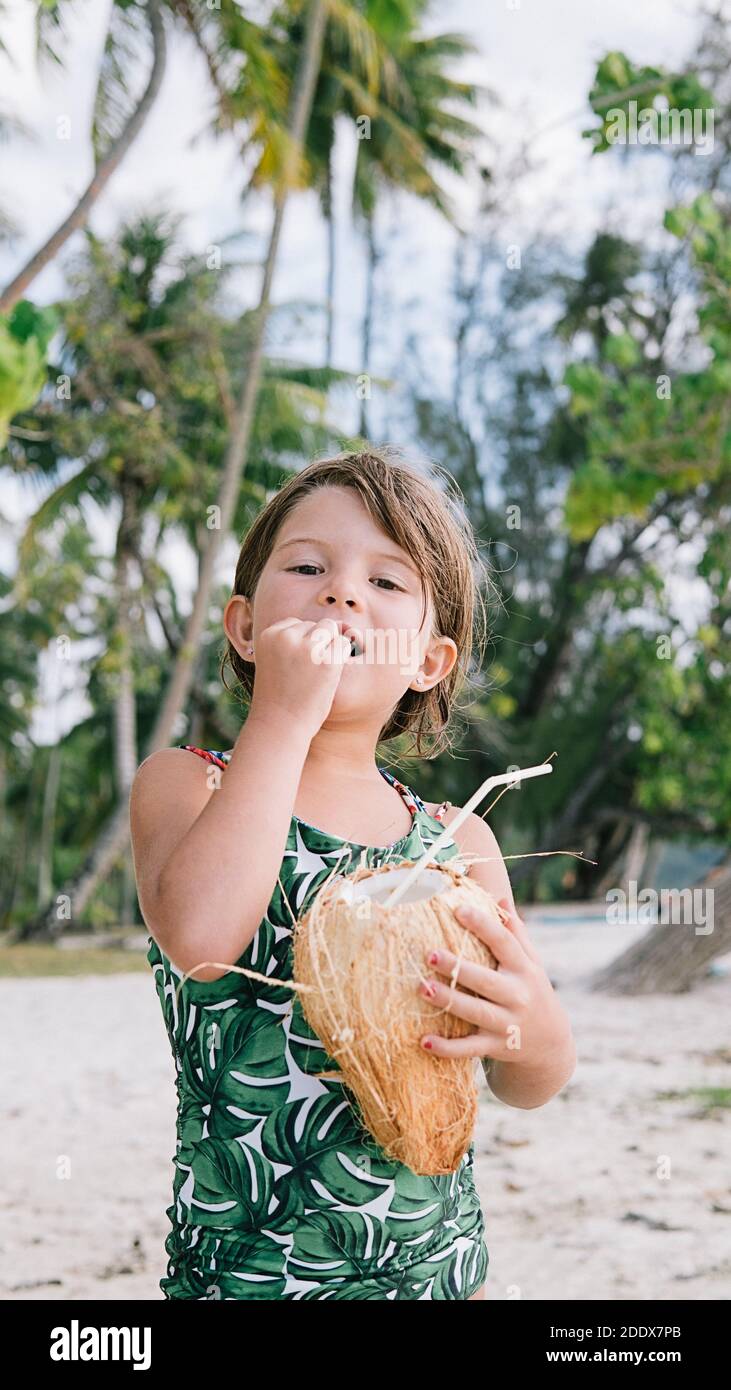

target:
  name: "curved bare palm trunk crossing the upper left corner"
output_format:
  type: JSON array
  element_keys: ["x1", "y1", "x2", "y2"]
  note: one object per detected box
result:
[{"x1": 0, "y1": 0, "x2": 167, "y2": 314}]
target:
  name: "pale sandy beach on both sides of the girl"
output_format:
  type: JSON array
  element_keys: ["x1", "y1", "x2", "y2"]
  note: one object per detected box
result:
[{"x1": 0, "y1": 905, "x2": 731, "y2": 1301}]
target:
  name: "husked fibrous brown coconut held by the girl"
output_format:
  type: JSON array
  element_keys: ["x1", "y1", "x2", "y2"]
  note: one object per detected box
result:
[{"x1": 293, "y1": 860, "x2": 504, "y2": 1175}]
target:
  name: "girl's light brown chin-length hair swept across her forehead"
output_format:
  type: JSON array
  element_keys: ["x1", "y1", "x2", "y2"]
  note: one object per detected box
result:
[{"x1": 221, "y1": 445, "x2": 492, "y2": 758}]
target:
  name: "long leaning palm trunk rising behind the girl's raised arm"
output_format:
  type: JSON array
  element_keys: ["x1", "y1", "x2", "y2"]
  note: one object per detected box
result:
[{"x1": 15, "y1": 0, "x2": 328, "y2": 940}]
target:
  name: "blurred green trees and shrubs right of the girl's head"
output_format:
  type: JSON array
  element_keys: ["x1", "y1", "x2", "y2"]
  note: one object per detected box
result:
[{"x1": 405, "y1": 35, "x2": 731, "y2": 898}]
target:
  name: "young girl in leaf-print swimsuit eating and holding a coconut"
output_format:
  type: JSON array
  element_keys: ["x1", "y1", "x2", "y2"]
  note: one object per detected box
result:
[{"x1": 131, "y1": 449, "x2": 575, "y2": 1300}]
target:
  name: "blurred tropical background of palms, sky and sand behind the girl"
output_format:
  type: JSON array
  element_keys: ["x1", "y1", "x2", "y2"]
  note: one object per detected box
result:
[{"x1": 0, "y1": 0, "x2": 731, "y2": 1298}]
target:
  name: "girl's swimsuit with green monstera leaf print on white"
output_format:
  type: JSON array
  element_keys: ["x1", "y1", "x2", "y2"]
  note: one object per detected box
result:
[{"x1": 147, "y1": 744, "x2": 488, "y2": 1301}]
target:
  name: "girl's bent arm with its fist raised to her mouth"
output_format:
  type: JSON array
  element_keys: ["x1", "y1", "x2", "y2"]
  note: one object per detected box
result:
[{"x1": 129, "y1": 619, "x2": 350, "y2": 980}]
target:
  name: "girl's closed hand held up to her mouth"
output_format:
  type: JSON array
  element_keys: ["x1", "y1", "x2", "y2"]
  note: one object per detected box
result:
[{"x1": 249, "y1": 617, "x2": 350, "y2": 737}]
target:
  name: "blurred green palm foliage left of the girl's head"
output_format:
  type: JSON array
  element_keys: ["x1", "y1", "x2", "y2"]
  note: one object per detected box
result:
[{"x1": 0, "y1": 214, "x2": 350, "y2": 926}]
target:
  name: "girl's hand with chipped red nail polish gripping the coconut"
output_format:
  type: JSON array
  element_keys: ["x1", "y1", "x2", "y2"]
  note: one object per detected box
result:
[{"x1": 418, "y1": 898, "x2": 571, "y2": 1068}]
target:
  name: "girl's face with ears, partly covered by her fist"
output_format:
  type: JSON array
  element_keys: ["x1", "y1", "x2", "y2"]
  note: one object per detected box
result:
[{"x1": 229, "y1": 487, "x2": 457, "y2": 724}]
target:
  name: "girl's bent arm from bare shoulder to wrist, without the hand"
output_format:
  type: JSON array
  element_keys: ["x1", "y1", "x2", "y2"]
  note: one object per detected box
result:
[{"x1": 129, "y1": 714, "x2": 310, "y2": 980}]
